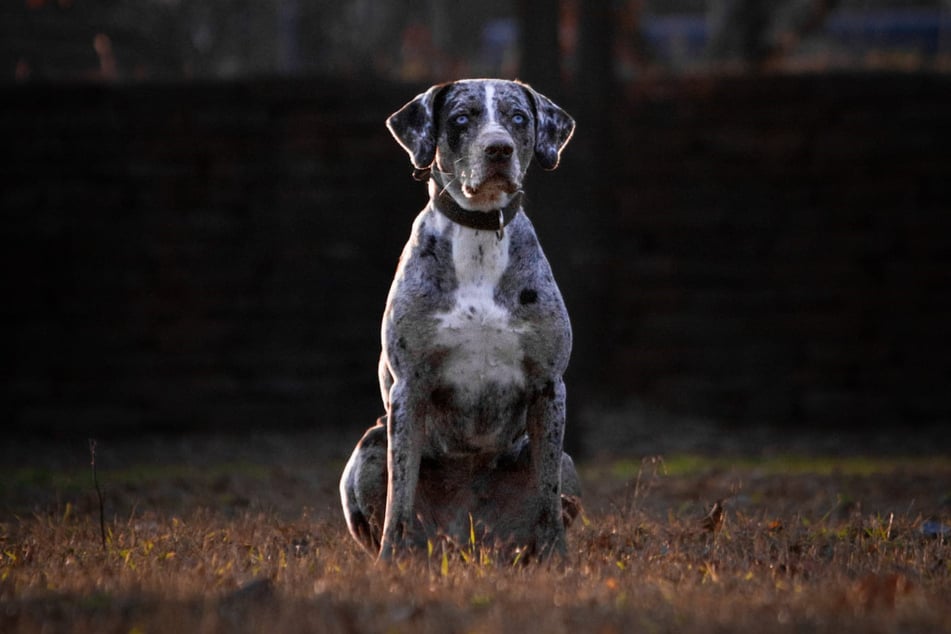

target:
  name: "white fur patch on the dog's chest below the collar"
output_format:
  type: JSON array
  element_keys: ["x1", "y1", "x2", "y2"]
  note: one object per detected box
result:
[{"x1": 436, "y1": 227, "x2": 527, "y2": 396}]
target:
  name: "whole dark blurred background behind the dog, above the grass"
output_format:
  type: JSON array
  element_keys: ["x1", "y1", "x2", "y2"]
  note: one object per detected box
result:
[{"x1": 0, "y1": 0, "x2": 951, "y2": 451}]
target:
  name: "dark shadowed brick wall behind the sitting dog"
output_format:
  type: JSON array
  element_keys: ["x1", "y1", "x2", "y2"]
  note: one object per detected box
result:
[{"x1": 0, "y1": 76, "x2": 951, "y2": 433}]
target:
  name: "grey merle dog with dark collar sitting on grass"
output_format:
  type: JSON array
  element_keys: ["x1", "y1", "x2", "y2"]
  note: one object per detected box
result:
[{"x1": 340, "y1": 79, "x2": 581, "y2": 560}]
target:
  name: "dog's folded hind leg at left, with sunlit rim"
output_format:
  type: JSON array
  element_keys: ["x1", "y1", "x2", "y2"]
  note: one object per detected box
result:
[{"x1": 340, "y1": 416, "x2": 386, "y2": 556}]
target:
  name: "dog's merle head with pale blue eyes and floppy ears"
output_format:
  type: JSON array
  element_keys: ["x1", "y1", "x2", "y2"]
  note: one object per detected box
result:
[{"x1": 386, "y1": 79, "x2": 575, "y2": 211}]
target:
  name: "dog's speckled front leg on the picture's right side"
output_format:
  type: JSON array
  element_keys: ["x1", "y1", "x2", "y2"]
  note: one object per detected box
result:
[{"x1": 527, "y1": 377, "x2": 567, "y2": 559}]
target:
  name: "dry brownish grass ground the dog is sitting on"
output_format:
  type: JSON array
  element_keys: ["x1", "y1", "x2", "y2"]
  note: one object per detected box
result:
[{"x1": 0, "y1": 438, "x2": 951, "y2": 633}]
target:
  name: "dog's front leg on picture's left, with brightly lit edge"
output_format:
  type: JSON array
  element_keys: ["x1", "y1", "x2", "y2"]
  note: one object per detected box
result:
[{"x1": 380, "y1": 385, "x2": 423, "y2": 561}]
